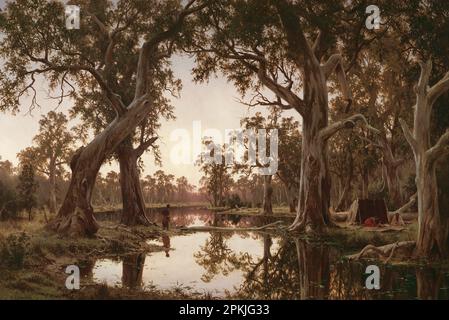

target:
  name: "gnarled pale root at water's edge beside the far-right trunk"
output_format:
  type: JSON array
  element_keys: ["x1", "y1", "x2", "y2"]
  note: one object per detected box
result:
[{"x1": 348, "y1": 241, "x2": 416, "y2": 263}]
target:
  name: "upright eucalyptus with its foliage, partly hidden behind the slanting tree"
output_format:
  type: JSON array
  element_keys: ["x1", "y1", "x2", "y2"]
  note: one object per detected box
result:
[{"x1": 71, "y1": 2, "x2": 176, "y2": 225}]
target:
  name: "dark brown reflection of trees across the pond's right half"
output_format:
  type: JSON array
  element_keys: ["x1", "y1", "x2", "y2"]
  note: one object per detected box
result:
[{"x1": 195, "y1": 233, "x2": 449, "y2": 300}]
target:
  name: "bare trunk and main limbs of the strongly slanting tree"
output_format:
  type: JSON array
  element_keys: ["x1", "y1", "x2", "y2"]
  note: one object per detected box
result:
[{"x1": 44, "y1": 0, "x2": 203, "y2": 236}]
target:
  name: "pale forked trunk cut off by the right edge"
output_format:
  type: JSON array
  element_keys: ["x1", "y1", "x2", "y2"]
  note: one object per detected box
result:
[{"x1": 401, "y1": 61, "x2": 449, "y2": 259}]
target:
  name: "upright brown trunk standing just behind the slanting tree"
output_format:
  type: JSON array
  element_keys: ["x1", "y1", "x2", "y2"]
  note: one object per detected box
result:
[{"x1": 117, "y1": 137, "x2": 149, "y2": 226}]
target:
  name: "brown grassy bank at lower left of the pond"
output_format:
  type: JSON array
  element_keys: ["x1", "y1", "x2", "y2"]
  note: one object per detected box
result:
[{"x1": 0, "y1": 217, "x2": 187, "y2": 299}]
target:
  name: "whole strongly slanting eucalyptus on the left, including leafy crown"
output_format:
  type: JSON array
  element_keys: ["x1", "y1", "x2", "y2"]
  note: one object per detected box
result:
[{"x1": 0, "y1": 0, "x2": 207, "y2": 235}]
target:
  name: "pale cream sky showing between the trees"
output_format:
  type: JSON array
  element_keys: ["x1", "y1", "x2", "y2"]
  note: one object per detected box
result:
[{"x1": 0, "y1": 0, "x2": 300, "y2": 184}]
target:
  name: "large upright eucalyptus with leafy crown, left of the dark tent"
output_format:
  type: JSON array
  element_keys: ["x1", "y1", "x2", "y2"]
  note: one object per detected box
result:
[{"x1": 187, "y1": 0, "x2": 380, "y2": 232}]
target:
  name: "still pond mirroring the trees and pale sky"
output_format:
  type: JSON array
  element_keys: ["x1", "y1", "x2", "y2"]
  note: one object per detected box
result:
[{"x1": 91, "y1": 210, "x2": 449, "y2": 299}]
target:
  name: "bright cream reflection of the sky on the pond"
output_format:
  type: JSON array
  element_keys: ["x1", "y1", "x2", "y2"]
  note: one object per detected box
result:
[{"x1": 93, "y1": 232, "x2": 278, "y2": 295}]
